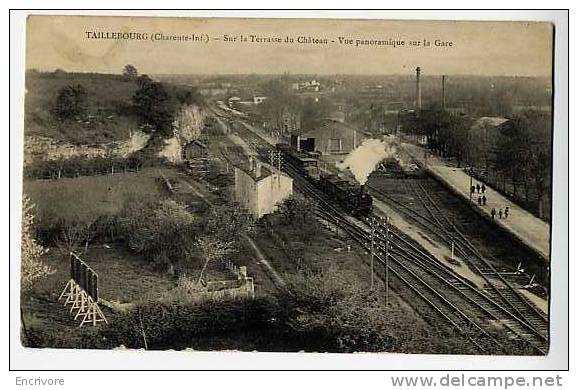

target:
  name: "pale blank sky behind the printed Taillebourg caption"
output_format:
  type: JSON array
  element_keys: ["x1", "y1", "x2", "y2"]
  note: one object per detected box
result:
[{"x1": 26, "y1": 15, "x2": 553, "y2": 77}]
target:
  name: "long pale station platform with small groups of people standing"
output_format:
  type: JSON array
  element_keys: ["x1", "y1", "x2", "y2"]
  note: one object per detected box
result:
[{"x1": 401, "y1": 143, "x2": 550, "y2": 263}]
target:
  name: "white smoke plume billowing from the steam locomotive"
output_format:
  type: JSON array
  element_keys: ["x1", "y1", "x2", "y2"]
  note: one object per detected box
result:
[{"x1": 337, "y1": 137, "x2": 399, "y2": 184}]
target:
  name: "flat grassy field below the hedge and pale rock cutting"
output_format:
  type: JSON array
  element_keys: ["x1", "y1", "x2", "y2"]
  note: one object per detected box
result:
[{"x1": 23, "y1": 168, "x2": 187, "y2": 223}]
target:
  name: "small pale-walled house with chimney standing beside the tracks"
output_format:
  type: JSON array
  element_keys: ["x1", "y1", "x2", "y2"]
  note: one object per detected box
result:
[{"x1": 235, "y1": 157, "x2": 293, "y2": 218}]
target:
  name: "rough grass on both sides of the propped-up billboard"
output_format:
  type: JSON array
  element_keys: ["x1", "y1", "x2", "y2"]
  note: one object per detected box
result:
[{"x1": 21, "y1": 245, "x2": 176, "y2": 348}]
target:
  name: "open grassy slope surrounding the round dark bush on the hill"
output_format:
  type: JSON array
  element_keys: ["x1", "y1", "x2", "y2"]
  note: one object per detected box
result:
[{"x1": 24, "y1": 72, "x2": 143, "y2": 144}]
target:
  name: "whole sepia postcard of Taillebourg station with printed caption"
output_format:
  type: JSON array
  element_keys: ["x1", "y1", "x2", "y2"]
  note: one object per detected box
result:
[{"x1": 18, "y1": 14, "x2": 556, "y2": 357}]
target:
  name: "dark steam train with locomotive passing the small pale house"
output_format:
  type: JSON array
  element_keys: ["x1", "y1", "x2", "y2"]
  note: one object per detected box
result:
[{"x1": 275, "y1": 143, "x2": 373, "y2": 217}]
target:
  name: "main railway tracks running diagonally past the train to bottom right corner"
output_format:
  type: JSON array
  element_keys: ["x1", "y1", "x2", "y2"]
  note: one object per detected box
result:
[{"x1": 210, "y1": 106, "x2": 548, "y2": 354}]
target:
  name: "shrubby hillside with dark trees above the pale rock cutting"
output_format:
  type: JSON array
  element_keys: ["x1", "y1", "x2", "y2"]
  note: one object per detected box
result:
[{"x1": 24, "y1": 70, "x2": 201, "y2": 145}]
